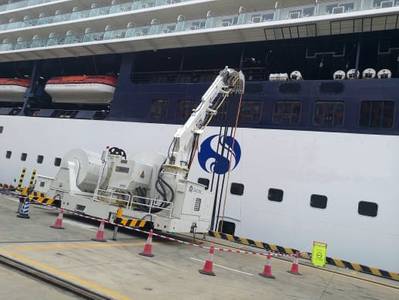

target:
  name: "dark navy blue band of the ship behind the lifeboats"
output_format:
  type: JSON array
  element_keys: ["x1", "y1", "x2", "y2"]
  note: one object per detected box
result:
[{"x1": 0, "y1": 30, "x2": 399, "y2": 134}]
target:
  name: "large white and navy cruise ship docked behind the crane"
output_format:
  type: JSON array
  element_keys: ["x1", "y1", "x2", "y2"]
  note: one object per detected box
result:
[{"x1": 0, "y1": 0, "x2": 399, "y2": 272}]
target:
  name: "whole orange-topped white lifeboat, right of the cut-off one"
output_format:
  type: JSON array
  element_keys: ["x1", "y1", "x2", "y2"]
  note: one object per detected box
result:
[{"x1": 45, "y1": 75, "x2": 117, "y2": 104}]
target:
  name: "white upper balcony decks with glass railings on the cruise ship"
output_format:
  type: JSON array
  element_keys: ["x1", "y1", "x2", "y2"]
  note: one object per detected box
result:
[{"x1": 0, "y1": 0, "x2": 399, "y2": 60}]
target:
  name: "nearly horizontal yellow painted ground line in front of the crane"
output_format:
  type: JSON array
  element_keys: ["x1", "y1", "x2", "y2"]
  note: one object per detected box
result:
[{"x1": 4, "y1": 241, "x2": 145, "y2": 251}]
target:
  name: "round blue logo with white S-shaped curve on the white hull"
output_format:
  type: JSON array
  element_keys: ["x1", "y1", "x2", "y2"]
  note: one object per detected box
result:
[{"x1": 198, "y1": 134, "x2": 241, "y2": 175}]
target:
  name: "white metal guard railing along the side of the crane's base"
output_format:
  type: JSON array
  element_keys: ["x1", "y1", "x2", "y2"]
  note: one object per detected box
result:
[{"x1": 93, "y1": 189, "x2": 173, "y2": 218}]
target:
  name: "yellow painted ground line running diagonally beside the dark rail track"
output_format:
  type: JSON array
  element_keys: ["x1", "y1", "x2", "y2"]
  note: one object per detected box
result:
[{"x1": 0, "y1": 250, "x2": 131, "y2": 300}]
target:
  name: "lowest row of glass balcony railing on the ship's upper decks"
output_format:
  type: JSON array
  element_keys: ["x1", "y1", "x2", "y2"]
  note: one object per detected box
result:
[{"x1": 0, "y1": 0, "x2": 399, "y2": 51}]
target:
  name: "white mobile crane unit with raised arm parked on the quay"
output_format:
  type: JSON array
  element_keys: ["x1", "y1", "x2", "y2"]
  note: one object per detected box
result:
[{"x1": 36, "y1": 67, "x2": 245, "y2": 232}]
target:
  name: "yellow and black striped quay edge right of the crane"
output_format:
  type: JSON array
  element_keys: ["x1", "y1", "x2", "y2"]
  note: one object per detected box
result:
[{"x1": 209, "y1": 231, "x2": 399, "y2": 281}]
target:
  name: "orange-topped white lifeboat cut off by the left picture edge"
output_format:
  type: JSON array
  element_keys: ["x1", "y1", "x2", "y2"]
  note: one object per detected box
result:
[{"x1": 0, "y1": 78, "x2": 30, "y2": 102}]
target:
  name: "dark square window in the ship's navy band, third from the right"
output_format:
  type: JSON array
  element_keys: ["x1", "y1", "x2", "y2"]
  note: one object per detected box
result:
[{"x1": 273, "y1": 101, "x2": 302, "y2": 125}]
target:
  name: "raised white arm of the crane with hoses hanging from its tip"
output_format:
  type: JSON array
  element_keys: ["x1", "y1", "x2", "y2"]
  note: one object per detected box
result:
[{"x1": 164, "y1": 67, "x2": 245, "y2": 174}]
